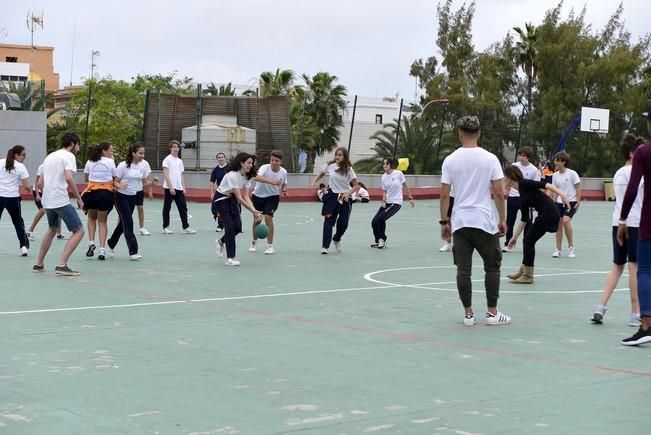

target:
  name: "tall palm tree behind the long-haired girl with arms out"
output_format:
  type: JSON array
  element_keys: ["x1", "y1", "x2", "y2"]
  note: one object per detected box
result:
[{"x1": 299, "y1": 72, "x2": 346, "y2": 171}]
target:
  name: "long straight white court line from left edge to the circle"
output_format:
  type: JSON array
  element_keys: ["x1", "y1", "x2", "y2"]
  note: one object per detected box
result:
[{"x1": 0, "y1": 285, "x2": 402, "y2": 316}]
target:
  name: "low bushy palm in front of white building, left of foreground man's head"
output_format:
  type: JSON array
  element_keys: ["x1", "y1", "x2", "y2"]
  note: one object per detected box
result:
[{"x1": 355, "y1": 116, "x2": 455, "y2": 175}]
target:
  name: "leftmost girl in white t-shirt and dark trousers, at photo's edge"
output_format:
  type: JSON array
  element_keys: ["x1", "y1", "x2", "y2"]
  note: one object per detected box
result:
[{"x1": 0, "y1": 145, "x2": 32, "y2": 257}]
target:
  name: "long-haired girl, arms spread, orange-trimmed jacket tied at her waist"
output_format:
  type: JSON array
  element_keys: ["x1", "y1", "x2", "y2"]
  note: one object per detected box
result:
[{"x1": 310, "y1": 147, "x2": 359, "y2": 254}]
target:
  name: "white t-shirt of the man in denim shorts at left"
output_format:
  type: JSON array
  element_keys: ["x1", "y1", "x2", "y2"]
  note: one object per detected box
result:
[{"x1": 41, "y1": 148, "x2": 77, "y2": 209}]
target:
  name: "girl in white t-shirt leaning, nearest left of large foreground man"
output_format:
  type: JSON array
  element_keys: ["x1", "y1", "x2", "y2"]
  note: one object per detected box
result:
[{"x1": 371, "y1": 158, "x2": 414, "y2": 249}]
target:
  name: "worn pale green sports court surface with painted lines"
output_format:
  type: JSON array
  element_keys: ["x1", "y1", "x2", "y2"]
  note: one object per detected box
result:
[{"x1": 0, "y1": 201, "x2": 651, "y2": 435}]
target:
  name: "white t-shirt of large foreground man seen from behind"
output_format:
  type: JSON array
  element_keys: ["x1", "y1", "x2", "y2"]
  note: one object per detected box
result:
[{"x1": 441, "y1": 147, "x2": 504, "y2": 234}]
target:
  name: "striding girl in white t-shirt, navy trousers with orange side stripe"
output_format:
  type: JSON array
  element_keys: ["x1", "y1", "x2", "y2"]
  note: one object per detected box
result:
[{"x1": 107, "y1": 144, "x2": 159, "y2": 261}]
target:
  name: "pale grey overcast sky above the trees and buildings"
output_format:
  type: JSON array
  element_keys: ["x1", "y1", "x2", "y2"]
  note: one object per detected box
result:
[{"x1": 0, "y1": 0, "x2": 649, "y2": 100}]
